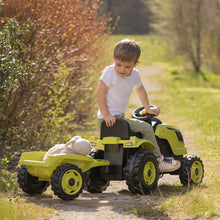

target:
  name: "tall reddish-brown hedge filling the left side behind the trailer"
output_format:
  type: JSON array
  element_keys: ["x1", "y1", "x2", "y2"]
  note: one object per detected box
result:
[{"x1": 0, "y1": 0, "x2": 111, "y2": 155}]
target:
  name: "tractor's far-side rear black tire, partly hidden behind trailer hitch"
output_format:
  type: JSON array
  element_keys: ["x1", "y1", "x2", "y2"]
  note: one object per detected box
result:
[{"x1": 85, "y1": 149, "x2": 110, "y2": 193}]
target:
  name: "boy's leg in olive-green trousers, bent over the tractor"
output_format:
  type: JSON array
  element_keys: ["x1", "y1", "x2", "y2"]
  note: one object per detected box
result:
[{"x1": 124, "y1": 118, "x2": 161, "y2": 157}]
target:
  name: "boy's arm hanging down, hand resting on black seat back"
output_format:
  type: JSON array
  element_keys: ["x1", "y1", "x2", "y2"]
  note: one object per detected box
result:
[{"x1": 97, "y1": 80, "x2": 116, "y2": 127}]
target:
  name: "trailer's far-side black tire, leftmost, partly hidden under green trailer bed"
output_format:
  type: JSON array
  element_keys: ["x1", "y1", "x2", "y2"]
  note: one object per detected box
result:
[{"x1": 17, "y1": 165, "x2": 49, "y2": 195}]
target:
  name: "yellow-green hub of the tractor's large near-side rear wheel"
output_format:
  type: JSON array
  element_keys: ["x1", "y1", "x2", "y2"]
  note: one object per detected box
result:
[{"x1": 143, "y1": 161, "x2": 156, "y2": 185}]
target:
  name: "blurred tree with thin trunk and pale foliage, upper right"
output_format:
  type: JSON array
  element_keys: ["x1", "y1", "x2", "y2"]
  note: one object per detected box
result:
[{"x1": 153, "y1": 0, "x2": 220, "y2": 77}]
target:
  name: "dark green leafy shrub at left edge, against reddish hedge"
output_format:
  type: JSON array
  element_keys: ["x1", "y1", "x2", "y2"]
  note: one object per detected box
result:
[{"x1": 0, "y1": 19, "x2": 28, "y2": 156}]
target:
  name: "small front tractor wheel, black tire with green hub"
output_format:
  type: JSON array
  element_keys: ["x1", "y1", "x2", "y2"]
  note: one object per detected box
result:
[{"x1": 179, "y1": 156, "x2": 204, "y2": 186}]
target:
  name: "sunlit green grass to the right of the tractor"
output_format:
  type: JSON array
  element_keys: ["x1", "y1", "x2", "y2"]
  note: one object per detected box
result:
[{"x1": 152, "y1": 69, "x2": 220, "y2": 218}]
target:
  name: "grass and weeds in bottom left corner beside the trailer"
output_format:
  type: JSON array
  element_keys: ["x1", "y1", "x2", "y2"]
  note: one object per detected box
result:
[{"x1": 0, "y1": 166, "x2": 55, "y2": 220}]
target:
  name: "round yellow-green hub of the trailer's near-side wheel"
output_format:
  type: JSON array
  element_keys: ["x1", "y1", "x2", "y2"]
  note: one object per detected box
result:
[{"x1": 61, "y1": 170, "x2": 83, "y2": 195}]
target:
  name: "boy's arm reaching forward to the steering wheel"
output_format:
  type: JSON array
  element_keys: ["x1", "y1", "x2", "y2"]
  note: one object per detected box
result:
[{"x1": 136, "y1": 85, "x2": 160, "y2": 116}]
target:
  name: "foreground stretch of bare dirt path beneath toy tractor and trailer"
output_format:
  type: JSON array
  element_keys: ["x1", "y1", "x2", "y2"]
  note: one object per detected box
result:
[{"x1": 35, "y1": 181, "x2": 160, "y2": 220}]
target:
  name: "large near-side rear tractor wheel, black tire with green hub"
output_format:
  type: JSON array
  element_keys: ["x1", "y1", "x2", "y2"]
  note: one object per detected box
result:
[{"x1": 124, "y1": 149, "x2": 159, "y2": 194}]
